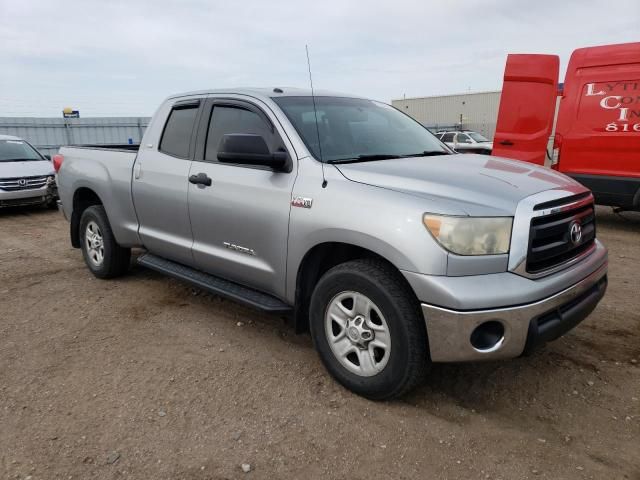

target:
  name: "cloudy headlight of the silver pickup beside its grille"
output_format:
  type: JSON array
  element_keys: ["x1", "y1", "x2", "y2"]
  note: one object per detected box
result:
[{"x1": 422, "y1": 213, "x2": 513, "y2": 255}]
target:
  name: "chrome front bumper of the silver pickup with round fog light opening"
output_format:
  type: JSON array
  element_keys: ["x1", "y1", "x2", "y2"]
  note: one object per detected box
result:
[{"x1": 422, "y1": 260, "x2": 608, "y2": 362}]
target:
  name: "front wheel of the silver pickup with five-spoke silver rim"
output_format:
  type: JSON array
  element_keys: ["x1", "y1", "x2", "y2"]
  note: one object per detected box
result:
[{"x1": 309, "y1": 259, "x2": 431, "y2": 400}]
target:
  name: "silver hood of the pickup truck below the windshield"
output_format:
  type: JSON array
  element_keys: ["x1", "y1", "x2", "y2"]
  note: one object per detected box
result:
[{"x1": 335, "y1": 154, "x2": 585, "y2": 216}]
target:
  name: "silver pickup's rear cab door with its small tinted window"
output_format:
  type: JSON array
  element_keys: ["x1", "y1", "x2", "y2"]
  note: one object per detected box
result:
[{"x1": 132, "y1": 99, "x2": 203, "y2": 265}]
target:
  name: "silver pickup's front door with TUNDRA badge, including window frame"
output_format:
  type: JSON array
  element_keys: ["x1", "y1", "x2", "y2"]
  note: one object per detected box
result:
[{"x1": 189, "y1": 99, "x2": 296, "y2": 297}]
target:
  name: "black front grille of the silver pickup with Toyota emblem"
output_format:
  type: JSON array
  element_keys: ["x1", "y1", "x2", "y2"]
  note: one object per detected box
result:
[{"x1": 527, "y1": 199, "x2": 596, "y2": 273}]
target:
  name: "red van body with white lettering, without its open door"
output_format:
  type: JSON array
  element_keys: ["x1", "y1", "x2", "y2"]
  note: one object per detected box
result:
[{"x1": 556, "y1": 43, "x2": 640, "y2": 207}]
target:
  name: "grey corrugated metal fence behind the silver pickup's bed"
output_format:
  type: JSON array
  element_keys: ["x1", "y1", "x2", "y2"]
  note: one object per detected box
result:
[{"x1": 0, "y1": 117, "x2": 150, "y2": 155}]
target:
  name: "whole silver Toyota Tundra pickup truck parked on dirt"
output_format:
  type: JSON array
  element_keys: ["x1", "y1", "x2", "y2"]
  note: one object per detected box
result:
[{"x1": 54, "y1": 88, "x2": 607, "y2": 399}]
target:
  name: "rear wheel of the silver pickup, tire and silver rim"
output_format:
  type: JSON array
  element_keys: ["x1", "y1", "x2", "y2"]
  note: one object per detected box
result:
[{"x1": 79, "y1": 205, "x2": 131, "y2": 278}]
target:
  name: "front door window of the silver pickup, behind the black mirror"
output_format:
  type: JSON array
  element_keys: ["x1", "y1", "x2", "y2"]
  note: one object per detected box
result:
[{"x1": 204, "y1": 105, "x2": 280, "y2": 162}]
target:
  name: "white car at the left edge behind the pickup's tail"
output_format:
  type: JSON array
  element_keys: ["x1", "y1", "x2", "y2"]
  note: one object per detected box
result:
[{"x1": 0, "y1": 135, "x2": 58, "y2": 208}]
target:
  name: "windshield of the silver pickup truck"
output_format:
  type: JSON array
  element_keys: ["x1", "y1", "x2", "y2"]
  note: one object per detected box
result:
[{"x1": 273, "y1": 96, "x2": 451, "y2": 162}]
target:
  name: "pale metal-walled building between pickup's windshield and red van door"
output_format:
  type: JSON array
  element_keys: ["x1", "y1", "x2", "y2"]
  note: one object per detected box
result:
[{"x1": 391, "y1": 91, "x2": 500, "y2": 139}]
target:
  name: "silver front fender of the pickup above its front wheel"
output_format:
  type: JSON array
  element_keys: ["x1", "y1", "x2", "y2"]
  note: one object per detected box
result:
[{"x1": 286, "y1": 165, "x2": 447, "y2": 302}]
